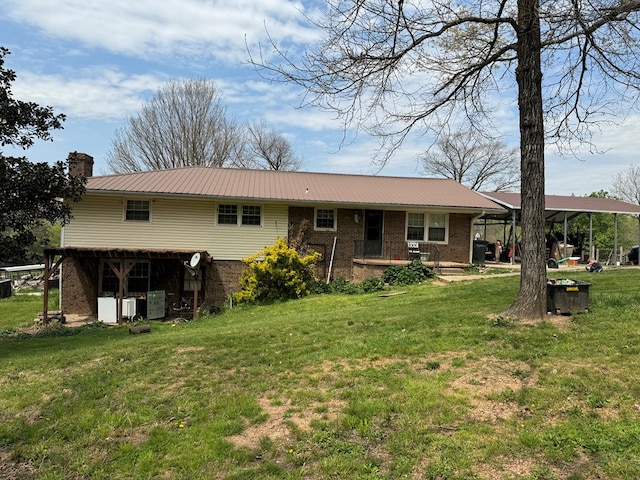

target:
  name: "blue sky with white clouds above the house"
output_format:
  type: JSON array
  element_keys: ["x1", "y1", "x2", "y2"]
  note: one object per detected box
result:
[{"x1": 0, "y1": 0, "x2": 640, "y2": 195}]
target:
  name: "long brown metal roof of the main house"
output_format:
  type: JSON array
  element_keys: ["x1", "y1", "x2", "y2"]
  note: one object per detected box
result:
[{"x1": 87, "y1": 167, "x2": 503, "y2": 211}]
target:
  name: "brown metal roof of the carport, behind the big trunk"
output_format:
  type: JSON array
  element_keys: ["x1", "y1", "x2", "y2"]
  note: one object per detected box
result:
[{"x1": 482, "y1": 192, "x2": 640, "y2": 221}]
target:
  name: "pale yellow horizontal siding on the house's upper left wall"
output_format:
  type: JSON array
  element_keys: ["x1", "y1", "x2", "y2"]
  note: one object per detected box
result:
[{"x1": 62, "y1": 195, "x2": 288, "y2": 260}]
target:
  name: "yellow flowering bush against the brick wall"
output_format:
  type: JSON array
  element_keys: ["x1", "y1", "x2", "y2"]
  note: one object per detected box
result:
[{"x1": 233, "y1": 238, "x2": 321, "y2": 303}]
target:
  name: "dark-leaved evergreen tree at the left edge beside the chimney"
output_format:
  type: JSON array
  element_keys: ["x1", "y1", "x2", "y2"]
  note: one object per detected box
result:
[{"x1": 0, "y1": 47, "x2": 84, "y2": 264}]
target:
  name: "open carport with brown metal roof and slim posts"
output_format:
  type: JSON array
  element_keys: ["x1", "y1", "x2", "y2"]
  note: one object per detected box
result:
[{"x1": 476, "y1": 192, "x2": 640, "y2": 265}]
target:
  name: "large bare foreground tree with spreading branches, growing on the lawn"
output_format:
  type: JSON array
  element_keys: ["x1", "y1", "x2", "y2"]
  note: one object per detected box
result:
[{"x1": 253, "y1": 0, "x2": 640, "y2": 319}]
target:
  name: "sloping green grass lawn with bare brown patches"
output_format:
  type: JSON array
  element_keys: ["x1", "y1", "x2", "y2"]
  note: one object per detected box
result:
[{"x1": 0, "y1": 268, "x2": 640, "y2": 480}]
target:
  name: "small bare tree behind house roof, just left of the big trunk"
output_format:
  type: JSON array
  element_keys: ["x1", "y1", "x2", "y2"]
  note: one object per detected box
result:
[{"x1": 420, "y1": 129, "x2": 520, "y2": 192}]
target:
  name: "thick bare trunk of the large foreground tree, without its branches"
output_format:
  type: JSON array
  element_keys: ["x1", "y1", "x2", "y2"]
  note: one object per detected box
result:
[{"x1": 506, "y1": 0, "x2": 547, "y2": 319}]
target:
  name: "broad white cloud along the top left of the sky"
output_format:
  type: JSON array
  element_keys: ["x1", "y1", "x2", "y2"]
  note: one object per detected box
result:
[{"x1": 0, "y1": 0, "x2": 317, "y2": 62}]
